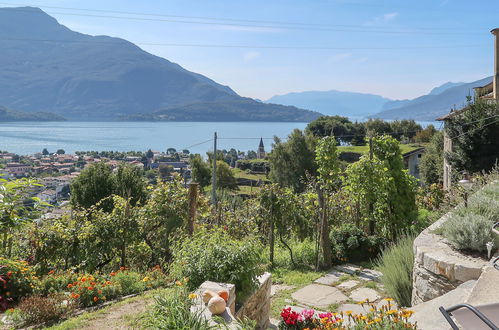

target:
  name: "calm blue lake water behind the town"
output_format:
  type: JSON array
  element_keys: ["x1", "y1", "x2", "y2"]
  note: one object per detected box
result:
[{"x1": 0, "y1": 122, "x2": 307, "y2": 155}]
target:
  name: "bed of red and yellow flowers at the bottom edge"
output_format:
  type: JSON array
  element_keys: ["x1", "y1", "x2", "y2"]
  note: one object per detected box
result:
[{"x1": 279, "y1": 298, "x2": 417, "y2": 330}]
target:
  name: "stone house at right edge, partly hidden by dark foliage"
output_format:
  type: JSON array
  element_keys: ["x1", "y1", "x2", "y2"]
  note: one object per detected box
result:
[{"x1": 437, "y1": 28, "x2": 499, "y2": 190}]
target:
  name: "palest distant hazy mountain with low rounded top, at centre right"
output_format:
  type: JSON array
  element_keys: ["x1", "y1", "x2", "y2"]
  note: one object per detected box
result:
[{"x1": 267, "y1": 90, "x2": 390, "y2": 117}]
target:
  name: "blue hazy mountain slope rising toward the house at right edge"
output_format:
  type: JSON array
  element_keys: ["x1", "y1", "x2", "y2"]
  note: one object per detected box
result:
[{"x1": 371, "y1": 77, "x2": 492, "y2": 121}]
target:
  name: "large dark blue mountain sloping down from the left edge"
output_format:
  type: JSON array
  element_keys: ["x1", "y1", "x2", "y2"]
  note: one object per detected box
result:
[{"x1": 0, "y1": 7, "x2": 320, "y2": 121}]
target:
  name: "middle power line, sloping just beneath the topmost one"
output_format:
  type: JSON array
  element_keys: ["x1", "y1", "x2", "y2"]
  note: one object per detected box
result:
[{"x1": 0, "y1": 8, "x2": 488, "y2": 35}]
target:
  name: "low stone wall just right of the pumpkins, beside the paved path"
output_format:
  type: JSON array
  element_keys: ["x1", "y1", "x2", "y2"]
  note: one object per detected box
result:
[{"x1": 236, "y1": 273, "x2": 272, "y2": 329}]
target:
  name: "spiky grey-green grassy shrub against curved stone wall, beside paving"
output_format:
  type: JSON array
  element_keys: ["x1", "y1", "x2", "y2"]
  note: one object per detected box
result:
[{"x1": 376, "y1": 235, "x2": 415, "y2": 306}]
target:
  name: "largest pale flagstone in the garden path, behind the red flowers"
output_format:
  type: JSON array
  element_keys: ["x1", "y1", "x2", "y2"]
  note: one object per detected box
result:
[{"x1": 291, "y1": 284, "x2": 348, "y2": 308}]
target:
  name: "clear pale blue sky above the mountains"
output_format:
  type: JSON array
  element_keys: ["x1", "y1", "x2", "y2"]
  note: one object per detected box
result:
[{"x1": 0, "y1": 0, "x2": 499, "y2": 100}]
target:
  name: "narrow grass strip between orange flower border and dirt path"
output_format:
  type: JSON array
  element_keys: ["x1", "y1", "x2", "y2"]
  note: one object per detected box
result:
[{"x1": 48, "y1": 288, "x2": 171, "y2": 330}]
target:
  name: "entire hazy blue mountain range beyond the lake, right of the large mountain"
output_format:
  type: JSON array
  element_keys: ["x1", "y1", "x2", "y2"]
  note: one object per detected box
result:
[{"x1": 267, "y1": 77, "x2": 492, "y2": 121}]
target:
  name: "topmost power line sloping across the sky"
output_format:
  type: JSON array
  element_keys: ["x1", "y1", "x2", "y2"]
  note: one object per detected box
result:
[{"x1": 0, "y1": 2, "x2": 482, "y2": 31}]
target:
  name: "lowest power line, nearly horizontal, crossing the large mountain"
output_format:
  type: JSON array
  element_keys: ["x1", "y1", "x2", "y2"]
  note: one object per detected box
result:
[{"x1": 0, "y1": 38, "x2": 486, "y2": 50}]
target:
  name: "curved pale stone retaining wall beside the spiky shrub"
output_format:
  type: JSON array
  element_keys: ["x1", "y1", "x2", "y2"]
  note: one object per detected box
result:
[{"x1": 412, "y1": 213, "x2": 487, "y2": 306}]
